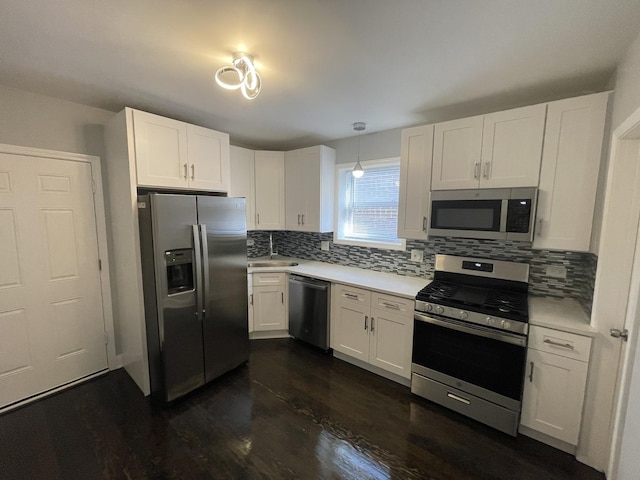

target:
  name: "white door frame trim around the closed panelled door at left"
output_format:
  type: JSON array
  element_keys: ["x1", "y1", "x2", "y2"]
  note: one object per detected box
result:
[{"x1": 0, "y1": 143, "x2": 117, "y2": 370}]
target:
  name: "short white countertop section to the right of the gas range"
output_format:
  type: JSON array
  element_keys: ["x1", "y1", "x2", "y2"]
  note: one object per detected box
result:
[{"x1": 529, "y1": 295, "x2": 598, "y2": 337}]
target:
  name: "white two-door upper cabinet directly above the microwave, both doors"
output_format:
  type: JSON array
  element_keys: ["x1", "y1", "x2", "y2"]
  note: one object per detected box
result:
[{"x1": 431, "y1": 104, "x2": 546, "y2": 190}]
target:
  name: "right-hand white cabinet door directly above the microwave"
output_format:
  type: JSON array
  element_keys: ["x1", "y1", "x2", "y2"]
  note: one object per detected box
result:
[{"x1": 480, "y1": 104, "x2": 547, "y2": 188}]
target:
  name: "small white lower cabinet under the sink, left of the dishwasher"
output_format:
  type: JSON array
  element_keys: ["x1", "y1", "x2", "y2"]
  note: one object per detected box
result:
[{"x1": 249, "y1": 272, "x2": 289, "y2": 332}]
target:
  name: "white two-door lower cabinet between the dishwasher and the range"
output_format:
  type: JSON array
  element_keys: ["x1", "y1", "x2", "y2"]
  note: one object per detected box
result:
[{"x1": 331, "y1": 284, "x2": 414, "y2": 379}]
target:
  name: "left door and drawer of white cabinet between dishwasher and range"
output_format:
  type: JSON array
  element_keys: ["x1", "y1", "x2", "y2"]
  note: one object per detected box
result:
[{"x1": 331, "y1": 285, "x2": 371, "y2": 362}]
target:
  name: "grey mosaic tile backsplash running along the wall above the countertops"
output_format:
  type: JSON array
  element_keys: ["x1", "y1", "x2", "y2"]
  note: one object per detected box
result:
[{"x1": 248, "y1": 231, "x2": 597, "y2": 312}]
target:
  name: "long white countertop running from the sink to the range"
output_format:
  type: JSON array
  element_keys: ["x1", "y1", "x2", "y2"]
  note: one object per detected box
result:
[{"x1": 249, "y1": 257, "x2": 431, "y2": 300}]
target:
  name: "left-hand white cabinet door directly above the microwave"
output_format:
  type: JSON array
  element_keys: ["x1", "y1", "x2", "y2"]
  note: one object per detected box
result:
[{"x1": 431, "y1": 116, "x2": 483, "y2": 190}]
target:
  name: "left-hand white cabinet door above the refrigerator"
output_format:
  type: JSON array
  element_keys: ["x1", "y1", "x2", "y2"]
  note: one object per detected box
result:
[{"x1": 133, "y1": 110, "x2": 189, "y2": 188}]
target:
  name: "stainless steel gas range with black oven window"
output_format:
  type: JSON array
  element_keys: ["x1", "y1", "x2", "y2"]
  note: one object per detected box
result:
[{"x1": 411, "y1": 255, "x2": 529, "y2": 436}]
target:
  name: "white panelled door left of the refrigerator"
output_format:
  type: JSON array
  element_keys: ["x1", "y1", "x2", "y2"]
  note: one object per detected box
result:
[{"x1": 0, "y1": 154, "x2": 107, "y2": 407}]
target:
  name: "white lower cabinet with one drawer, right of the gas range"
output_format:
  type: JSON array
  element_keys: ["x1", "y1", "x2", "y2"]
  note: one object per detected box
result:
[{"x1": 520, "y1": 326, "x2": 591, "y2": 446}]
